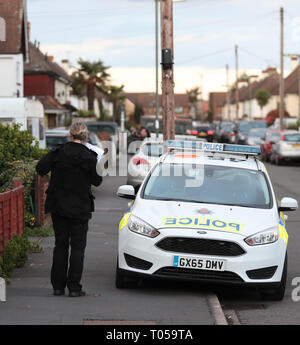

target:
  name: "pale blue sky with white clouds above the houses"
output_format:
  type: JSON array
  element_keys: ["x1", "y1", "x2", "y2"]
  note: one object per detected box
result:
[{"x1": 27, "y1": 0, "x2": 300, "y2": 96}]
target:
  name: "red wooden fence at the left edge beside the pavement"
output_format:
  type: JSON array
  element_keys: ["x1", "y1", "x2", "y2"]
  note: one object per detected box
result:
[{"x1": 0, "y1": 183, "x2": 24, "y2": 257}]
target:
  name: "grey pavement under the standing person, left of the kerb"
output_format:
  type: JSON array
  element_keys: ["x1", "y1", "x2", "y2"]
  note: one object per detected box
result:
[{"x1": 0, "y1": 177, "x2": 215, "y2": 325}]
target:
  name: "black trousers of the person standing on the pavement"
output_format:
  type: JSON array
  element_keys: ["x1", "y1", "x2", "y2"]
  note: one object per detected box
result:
[{"x1": 51, "y1": 213, "x2": 88, "y2": 292}]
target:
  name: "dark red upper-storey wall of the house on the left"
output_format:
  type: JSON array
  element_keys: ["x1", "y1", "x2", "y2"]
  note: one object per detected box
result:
[{"x1": 24, "y1": 74, "x2": 55, "y2": 97}]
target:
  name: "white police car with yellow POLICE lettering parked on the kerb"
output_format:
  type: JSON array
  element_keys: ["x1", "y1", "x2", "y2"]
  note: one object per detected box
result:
[{"x1": 116, "y1": 141, "x2": 298, "y2": 300}]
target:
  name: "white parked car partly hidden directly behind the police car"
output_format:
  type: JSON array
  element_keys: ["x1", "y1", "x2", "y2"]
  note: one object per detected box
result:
[{"x1": 127, "y1": 139, "x2": 164, "y2": 191}]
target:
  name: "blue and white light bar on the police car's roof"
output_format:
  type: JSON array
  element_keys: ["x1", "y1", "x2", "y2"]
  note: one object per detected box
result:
[{"x1": 165, "y1": 140, "x2": 261, "y2": 156}]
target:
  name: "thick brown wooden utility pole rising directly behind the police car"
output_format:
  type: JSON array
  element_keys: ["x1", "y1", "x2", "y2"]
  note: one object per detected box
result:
[{"x1": 160, "y1": 0, "x2": 175, "y2": 140}]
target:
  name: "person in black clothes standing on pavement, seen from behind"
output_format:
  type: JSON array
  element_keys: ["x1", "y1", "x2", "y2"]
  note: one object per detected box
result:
[{"x1": 36, "y1": 122, "x2": 102, "y2": 297}]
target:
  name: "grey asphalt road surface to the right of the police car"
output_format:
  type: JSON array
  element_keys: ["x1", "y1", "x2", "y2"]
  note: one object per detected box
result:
[{"x1": 215, "y1": 164, "x2": 300, "y2": 325}]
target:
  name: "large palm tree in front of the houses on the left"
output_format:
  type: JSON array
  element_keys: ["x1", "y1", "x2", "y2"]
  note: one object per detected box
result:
[{"x1": 72, "y1": 59, "x2": 110, "y2": 111}]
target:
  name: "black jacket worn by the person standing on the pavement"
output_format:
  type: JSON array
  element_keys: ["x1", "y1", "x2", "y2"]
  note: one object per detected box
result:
[{"x1": 36, "y1": 142, "x2": 102, "y2": 219}]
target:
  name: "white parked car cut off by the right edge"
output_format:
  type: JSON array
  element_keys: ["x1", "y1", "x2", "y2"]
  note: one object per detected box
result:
[{"x1": 270, "y1": 130, "x2": 300, "y2": 165}]
